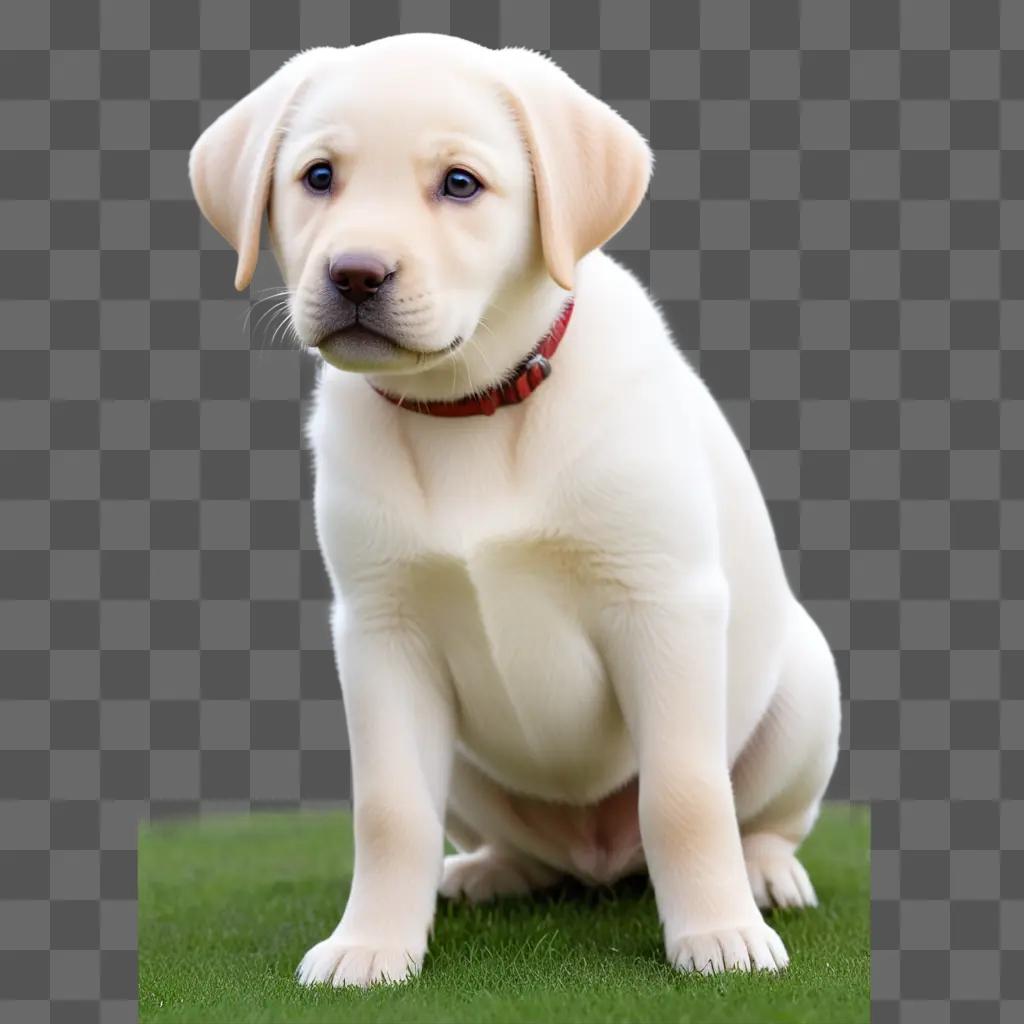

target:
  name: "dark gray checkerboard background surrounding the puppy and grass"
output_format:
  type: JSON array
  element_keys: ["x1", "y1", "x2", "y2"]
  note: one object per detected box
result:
[{"x1": 0, "y1": 0, "x2": 1024, "y2": 1024}]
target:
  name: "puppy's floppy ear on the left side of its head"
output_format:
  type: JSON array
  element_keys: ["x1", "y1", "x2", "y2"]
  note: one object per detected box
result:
[{"x1": 188, "y1": 46, "x2": 340, "y2": 292}]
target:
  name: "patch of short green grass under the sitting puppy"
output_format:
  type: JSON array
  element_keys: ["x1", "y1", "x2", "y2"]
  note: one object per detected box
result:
[{"x1": 138, "y1": 806, "x2": 870, "y2": 1024}]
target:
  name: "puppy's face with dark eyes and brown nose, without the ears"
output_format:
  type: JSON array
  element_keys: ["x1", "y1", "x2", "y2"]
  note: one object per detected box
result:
[{"x1": 270, "y1": 53, "x2": 543, "y2": 372}]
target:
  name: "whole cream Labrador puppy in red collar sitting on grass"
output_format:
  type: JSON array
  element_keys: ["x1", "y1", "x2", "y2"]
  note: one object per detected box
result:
[{"x1": 189, "y1": 35, "x2": 840, "y2": 985}]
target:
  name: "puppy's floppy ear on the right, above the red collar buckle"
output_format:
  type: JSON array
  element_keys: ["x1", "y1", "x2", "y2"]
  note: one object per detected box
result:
[{"x1": 501, "y1": 48, "x2": 653, "y2": 289}]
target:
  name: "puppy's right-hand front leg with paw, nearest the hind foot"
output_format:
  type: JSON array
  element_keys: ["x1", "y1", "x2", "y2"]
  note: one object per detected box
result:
[{"x1": 603, "y1": 574, "x2": 787, "y2": 973}]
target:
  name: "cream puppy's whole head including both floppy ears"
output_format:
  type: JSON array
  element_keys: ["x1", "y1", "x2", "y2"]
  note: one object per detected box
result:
[{"x1": 189, "y1": 35, "x2": 651, "y2": 373}]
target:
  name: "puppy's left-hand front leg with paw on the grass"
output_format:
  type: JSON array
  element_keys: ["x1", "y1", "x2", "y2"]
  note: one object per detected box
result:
[{"x1": 297, "y1": 627, "x2": 454, "y2": 986}]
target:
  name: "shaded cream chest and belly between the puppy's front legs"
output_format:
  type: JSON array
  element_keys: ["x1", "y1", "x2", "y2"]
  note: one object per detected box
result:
[{"x1": 414, "y1": 543, "x2": 628, "y2": 799}]
